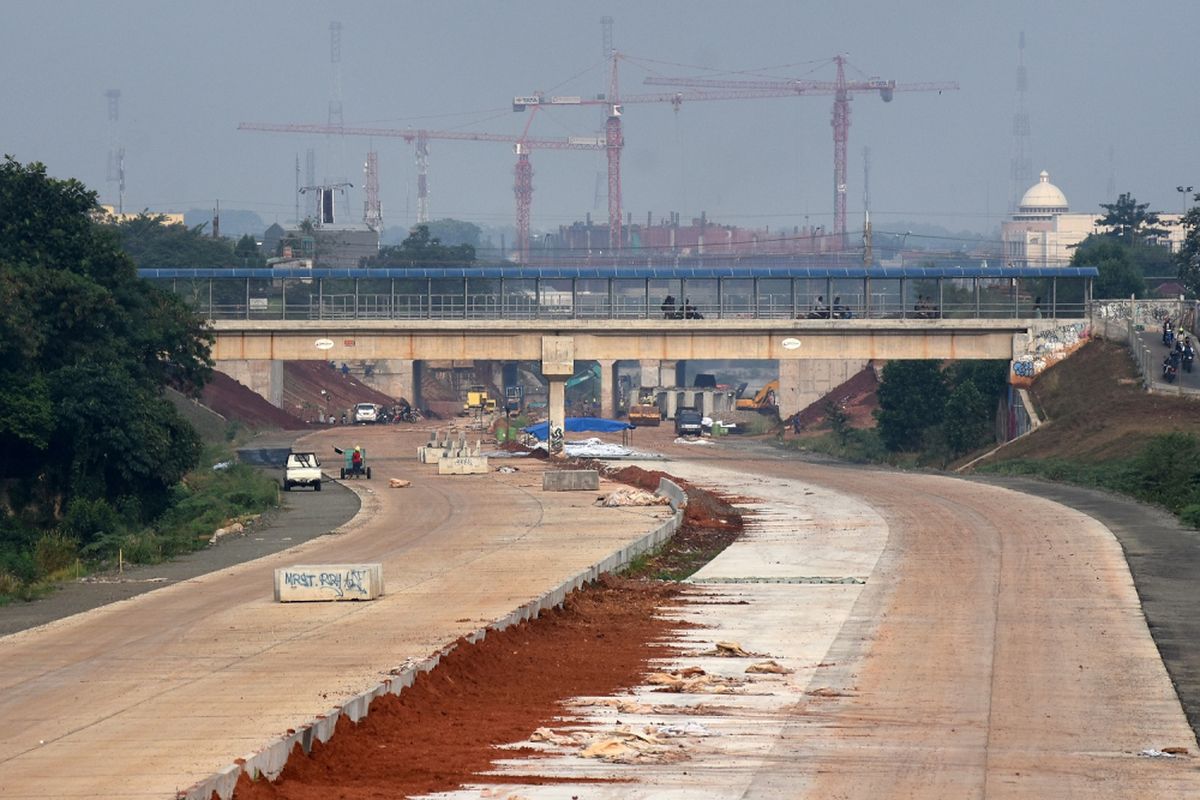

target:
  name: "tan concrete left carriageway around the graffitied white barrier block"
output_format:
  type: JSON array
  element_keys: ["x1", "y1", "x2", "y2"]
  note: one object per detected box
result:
[{"x1": 0, "y1": 427, "x2": 664, "y2": 800}]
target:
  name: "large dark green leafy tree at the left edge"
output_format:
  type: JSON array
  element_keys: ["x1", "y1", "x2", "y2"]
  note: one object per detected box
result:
[{"x1": 0, "y1": 157, "x2": 211, "y2": 537}]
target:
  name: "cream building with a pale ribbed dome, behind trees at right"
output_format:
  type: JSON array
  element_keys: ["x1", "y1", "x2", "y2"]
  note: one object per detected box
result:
[{"x1": 1000, "y1": 169, "x2": 1182, "y2": 266}]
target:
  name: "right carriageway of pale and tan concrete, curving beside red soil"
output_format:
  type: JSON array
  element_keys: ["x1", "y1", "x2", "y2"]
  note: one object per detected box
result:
[{"x1": 452, "y1": 432, "x2": 1200, "y2": 800}]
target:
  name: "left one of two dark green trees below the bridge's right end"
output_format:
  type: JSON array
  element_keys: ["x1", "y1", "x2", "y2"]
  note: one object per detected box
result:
[{"x1": 875, "y1": 360, "x2": 947, "y2": 451}]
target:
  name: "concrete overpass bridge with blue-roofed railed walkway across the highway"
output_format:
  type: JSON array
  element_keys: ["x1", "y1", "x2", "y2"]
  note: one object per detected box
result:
[{"x1": 139, "y1": 266, "x2": 1097, "y2": 438}]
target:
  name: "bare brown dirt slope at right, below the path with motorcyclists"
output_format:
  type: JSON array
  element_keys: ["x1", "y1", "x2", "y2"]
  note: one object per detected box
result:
[{"x1": 991, "y1": 339, "x2": 1200, "y2": 463}]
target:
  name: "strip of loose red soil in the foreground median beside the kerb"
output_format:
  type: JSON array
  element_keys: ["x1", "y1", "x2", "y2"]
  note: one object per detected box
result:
[{"x1": 234, "y1": 577, "x2": 679, "y2": 800}]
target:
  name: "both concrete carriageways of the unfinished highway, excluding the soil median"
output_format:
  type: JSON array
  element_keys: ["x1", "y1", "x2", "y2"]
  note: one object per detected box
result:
[{"x1": 0, "y1": 429, "x2": 1200, "y2": 799}]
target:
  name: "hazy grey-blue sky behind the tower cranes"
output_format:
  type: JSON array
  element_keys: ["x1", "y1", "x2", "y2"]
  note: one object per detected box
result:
[{"x1": 0, "y1": 0, "x2": 1200, "y2": 241}]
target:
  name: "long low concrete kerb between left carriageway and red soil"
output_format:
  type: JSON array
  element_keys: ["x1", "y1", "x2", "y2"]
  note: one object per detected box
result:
[{"x1": 176, "y1": 510, "x2": 685, "y2": 800}]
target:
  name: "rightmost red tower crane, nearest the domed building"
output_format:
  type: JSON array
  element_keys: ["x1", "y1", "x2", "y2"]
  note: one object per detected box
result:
[{"x1": 644, "y1": 55, "x2": 959, "y2": 247}]
